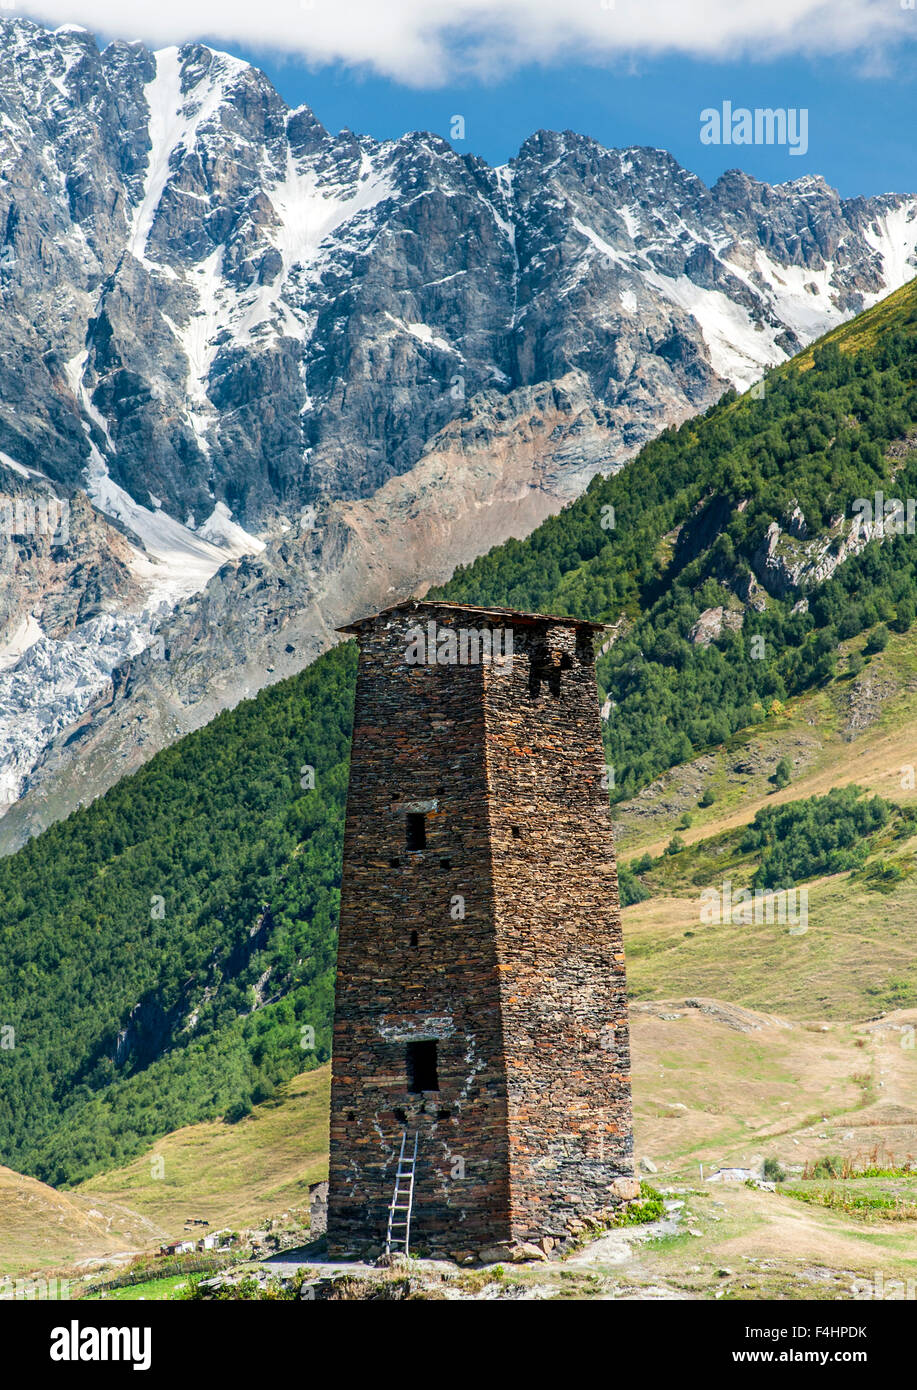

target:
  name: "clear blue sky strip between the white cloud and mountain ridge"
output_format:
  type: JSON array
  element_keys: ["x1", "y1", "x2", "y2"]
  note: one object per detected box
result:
[{"x1": 232, "y1": 45, "x2": 917, "y2": 197}]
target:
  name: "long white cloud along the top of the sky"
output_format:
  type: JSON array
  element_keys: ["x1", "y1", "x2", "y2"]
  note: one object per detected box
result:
[{"x1": 16, "y1": 0, "x2": 917, "y2": 86}]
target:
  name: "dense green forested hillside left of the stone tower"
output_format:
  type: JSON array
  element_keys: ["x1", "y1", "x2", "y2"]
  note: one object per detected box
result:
[{"x1": 0, "y1": 644, "x2": 356, "y2": 1183}]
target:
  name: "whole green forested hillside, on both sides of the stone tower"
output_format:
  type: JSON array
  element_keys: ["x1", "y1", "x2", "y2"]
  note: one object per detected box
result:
[{"x1": 0, "y1": 285, "x2": 917, "y2": 1184}]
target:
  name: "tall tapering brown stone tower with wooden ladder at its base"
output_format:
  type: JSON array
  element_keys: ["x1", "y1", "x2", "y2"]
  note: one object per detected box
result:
[{"x1": 328, "y1": 600, "x2": 636, "y2": 1255}]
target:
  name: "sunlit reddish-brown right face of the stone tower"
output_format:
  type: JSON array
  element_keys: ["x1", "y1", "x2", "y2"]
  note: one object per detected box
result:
[{"x1": 485, "y1": 626, "x2": 634, "y2": 1240}]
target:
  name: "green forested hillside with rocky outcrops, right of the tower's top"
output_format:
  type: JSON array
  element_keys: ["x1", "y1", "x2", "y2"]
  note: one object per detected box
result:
[{"x1": 440, "y1": 282, "x2": 917, "y2": 799}]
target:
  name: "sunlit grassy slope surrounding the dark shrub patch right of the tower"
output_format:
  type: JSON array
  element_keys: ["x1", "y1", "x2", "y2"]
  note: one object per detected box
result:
[{"x1": 614, "y1": 614, "x2": 917, "y2": 1019}]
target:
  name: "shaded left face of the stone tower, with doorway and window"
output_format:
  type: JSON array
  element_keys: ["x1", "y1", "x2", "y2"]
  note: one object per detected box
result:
[{"x1": 328, "y1": 619, "x2": 509, "y2": 1254}]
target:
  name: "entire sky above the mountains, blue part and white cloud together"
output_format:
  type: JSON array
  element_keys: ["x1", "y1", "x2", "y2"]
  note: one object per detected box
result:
[{"x1": 19, "y1": 0, "x2": 917, "y2": 196}]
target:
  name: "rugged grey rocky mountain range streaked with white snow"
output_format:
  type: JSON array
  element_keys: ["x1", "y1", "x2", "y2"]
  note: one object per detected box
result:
[{"x1": 0, "y1": 15, "x2": 917, "y2": 834}]
